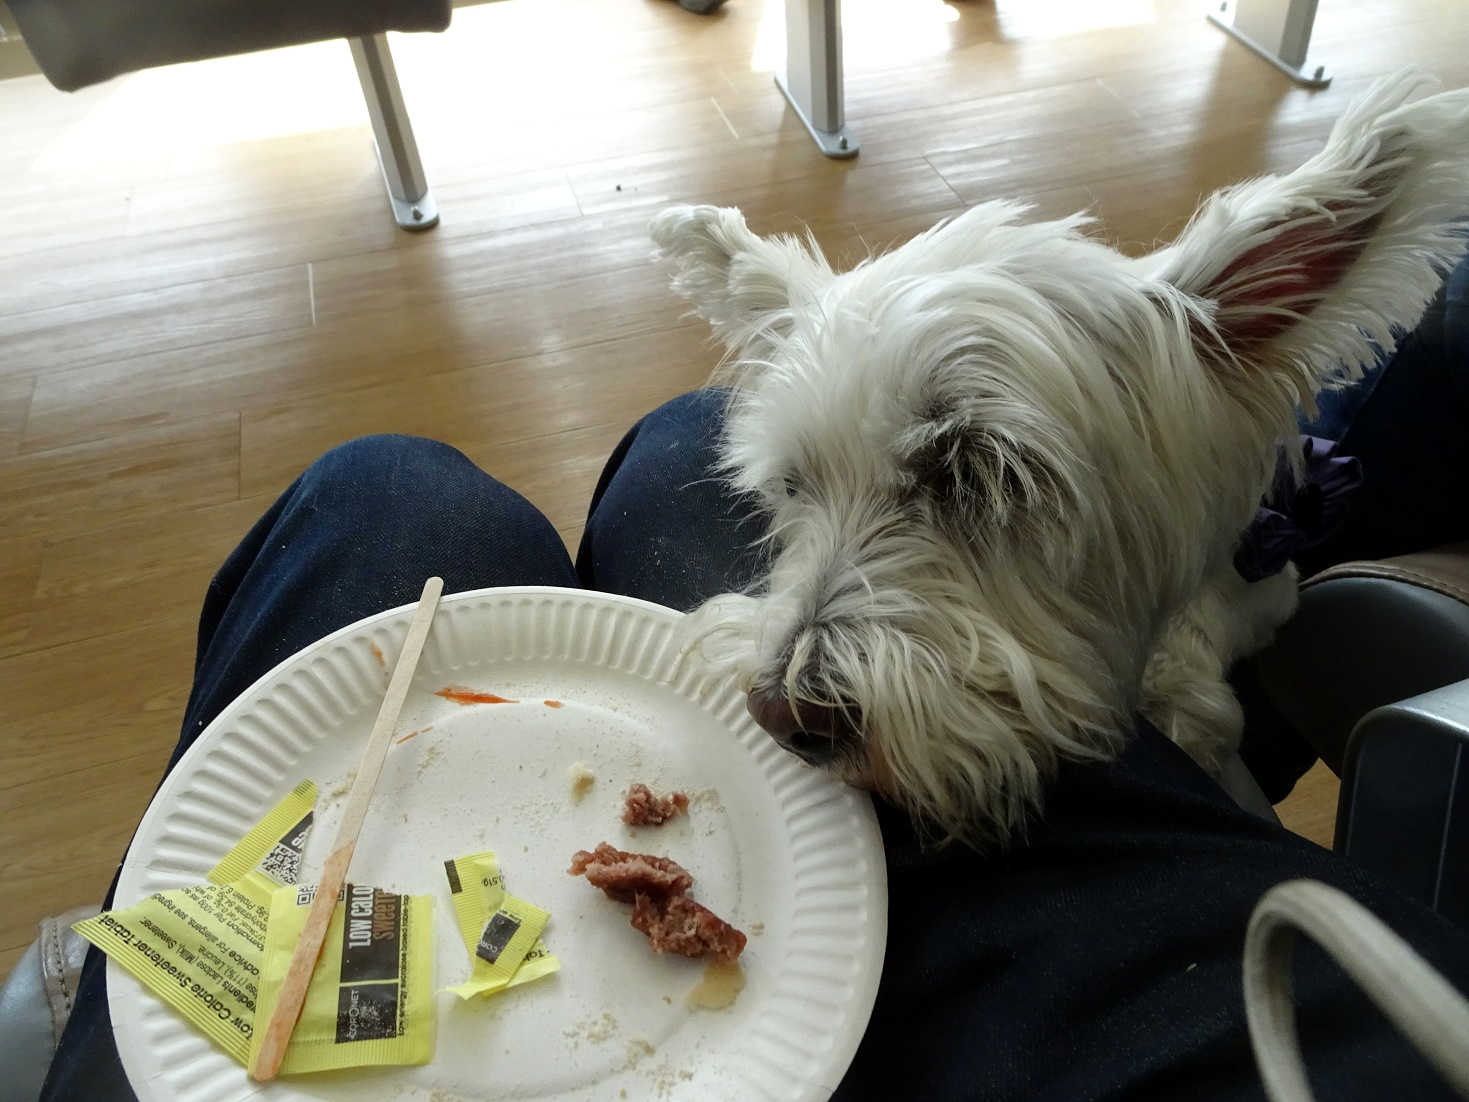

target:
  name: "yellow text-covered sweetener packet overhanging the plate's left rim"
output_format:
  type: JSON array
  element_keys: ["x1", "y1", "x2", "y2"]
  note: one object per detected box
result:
[{"x1": 72, "y1": 780, "x2": 316, "y2": 1064}]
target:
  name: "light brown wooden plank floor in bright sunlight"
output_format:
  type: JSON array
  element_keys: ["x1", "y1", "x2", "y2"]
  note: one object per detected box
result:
[{"x1": 0, "y1": 0, "x2": 1469, "y2": 973}]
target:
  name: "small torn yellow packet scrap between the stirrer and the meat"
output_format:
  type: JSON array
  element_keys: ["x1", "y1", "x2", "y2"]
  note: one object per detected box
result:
[{"x1": 444, "y1": 852, "x2": 561, "y2": 999}]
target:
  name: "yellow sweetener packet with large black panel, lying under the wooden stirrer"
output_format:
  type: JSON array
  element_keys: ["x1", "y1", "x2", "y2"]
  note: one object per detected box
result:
[{"x1": 250, "y1": 885, "x2": 436, "y2": 1076}]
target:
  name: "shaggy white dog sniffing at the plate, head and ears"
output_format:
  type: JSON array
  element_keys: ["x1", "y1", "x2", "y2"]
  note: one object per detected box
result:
[{"x1": 652, "y1": 75, "x2": 1469, "y2": 845}]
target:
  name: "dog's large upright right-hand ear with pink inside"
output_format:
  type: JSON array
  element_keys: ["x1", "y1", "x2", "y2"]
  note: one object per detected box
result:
[{"x1": 1149, "y1": 73, "x2": 1469, "y2": 404}]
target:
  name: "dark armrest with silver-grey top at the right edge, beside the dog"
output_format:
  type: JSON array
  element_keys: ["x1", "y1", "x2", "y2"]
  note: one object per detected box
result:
[{"x1": 1337, "y1": 680, "x2": 1469, "y2": 926}]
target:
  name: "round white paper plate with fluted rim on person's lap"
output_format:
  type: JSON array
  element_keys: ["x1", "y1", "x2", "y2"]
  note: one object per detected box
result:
[{"x1": 107, "y1": 588, "x2": 887, "y2": 1102}]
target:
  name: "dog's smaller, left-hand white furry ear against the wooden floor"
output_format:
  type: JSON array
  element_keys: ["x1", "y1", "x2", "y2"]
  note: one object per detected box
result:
[{"x1": 651, "y1": 206, "x2": 831, "y2": 348}]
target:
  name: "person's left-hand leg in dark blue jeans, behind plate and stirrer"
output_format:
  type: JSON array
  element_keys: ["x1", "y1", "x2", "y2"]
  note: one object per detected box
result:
[{"x1": 41, "y1": 436, "x2": 576, "y2": 1099}]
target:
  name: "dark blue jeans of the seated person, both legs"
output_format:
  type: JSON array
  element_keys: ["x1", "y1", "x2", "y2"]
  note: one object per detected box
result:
[{"x1": 43, "y1": 379, "x2": 1469, "y2": 1102}]
